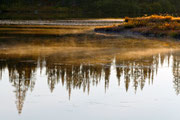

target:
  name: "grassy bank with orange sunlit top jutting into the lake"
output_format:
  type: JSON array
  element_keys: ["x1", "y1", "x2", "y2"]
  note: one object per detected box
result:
[{"x1": 95, "y1": 15, "x2": 180, "y2": 38}]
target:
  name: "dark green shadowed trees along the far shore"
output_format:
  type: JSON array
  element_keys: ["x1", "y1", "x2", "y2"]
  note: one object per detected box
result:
[{"x1": 0, "y1": 0, "x2": 180, "y2": 17}]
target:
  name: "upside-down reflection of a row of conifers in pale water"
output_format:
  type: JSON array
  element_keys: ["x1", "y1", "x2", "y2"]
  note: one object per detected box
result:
[{"x1": 0, "y1": 50, "x2": 180, "y2": 114}]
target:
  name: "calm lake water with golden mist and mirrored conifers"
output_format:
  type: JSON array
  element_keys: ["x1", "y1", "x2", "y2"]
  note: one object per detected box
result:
[{"x1": 0, "y1": 21, "x2": 180, "y2": 120}]
